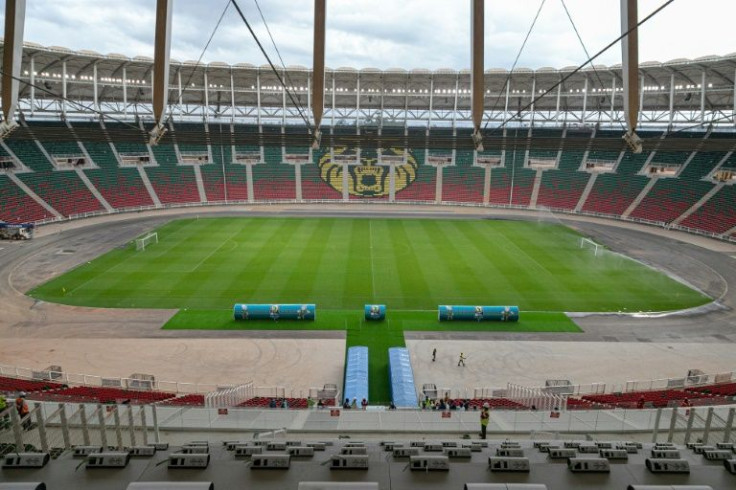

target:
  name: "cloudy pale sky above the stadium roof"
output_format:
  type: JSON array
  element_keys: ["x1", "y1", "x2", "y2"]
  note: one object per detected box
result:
[{"x1": 3, "y1": 0, "x2": 736, "y2": 69}]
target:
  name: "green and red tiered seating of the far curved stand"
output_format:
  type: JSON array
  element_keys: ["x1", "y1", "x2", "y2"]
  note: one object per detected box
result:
[{"x1": 0, "y1": 121, "x2": 736, "y2": 247}]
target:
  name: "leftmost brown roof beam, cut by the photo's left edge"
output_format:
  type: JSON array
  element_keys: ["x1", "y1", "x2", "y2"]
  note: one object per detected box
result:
[{"x1": 0, "y1": 0, "x2": 26, "y2": 140}]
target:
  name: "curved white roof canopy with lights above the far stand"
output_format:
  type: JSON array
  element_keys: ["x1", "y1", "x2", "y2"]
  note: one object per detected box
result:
[{"x1": 10, "y1": 42, "x2": 736, "y2": 117}]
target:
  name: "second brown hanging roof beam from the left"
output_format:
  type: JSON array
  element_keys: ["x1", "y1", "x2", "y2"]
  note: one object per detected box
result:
[{"x1": 149, "y1": 0, "x2": 174, "y2": 145}]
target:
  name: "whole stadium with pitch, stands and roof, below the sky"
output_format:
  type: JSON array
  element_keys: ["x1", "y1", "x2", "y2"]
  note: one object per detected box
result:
[{"x1": 0, "y1": 0, "x2": 736, "y2": 490}]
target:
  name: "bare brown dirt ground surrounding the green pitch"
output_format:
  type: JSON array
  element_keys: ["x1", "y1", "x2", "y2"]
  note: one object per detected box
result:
[{"x1": 0, "y1": 205, "x2": 736, "y2": 390}]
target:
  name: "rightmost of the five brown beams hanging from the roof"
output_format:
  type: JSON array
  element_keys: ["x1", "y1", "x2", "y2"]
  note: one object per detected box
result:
[{"x1": 621, "y1": 0, "x2": 642, "y2": 153}]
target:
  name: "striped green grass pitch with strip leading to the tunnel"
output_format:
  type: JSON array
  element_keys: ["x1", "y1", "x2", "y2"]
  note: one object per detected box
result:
[{"x1": 28, "y1": 218, "x2": 710, "y2": 400}]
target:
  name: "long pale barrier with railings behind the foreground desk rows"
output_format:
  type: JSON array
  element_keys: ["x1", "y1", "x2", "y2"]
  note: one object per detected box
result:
[{"x1": 0, "y1": 403, "x2": 736, "y2": 450}]
